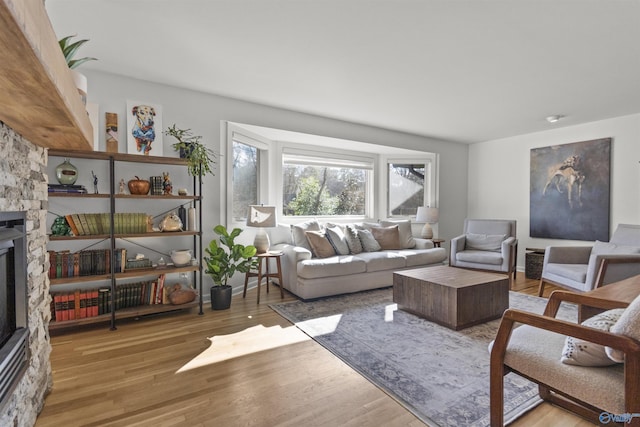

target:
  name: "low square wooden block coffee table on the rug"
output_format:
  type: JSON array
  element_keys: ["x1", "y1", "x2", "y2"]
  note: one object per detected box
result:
[{"x1": 393, "y1": 266, "x2": 509, "y2": 330}]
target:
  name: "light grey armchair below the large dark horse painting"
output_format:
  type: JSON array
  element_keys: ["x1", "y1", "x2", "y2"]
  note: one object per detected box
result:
[{"x1": 538, "y1": 224, "x2": 640, "y2": 296}]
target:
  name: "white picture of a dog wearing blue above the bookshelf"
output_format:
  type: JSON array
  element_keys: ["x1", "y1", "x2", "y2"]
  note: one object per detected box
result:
[{"x1": 127, "y1": 101, "x2": 162, "y2": 156}]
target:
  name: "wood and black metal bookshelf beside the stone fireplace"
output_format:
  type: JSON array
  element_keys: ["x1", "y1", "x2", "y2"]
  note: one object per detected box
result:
[{"x1": 48, "y1": 149, "x2": 203, "y2": 331}]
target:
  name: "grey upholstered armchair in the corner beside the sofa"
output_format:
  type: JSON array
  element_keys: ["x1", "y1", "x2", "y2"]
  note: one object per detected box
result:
[{"x1": 449, "y1": 219, "x2": 518, "y2": 279}]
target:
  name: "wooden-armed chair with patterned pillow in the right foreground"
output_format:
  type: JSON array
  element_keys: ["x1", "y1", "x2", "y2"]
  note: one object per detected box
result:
[{"x1": 489, "y1": 291, "x2": 640, "y2": 427}]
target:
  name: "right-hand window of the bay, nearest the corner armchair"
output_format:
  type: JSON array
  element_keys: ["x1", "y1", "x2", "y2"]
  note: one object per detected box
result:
[{"x1": 387, "y1": 159, "x2": 434, "y2": 217}]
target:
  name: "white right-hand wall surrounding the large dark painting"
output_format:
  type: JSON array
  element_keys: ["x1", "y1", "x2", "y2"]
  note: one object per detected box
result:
[{"x1": 468, "y1": 114, "x2": 640, "y2": 268}]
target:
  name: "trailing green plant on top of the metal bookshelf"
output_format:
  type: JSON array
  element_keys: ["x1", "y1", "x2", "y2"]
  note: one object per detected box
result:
[{"x1": 164, "y1": 124, "x2": 216, "y2": 179}]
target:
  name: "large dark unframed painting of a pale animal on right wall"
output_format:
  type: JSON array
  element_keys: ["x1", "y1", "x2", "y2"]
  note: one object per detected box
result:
[{"x1": 529, "y1": 138, "x2": 611, "y2": 242}]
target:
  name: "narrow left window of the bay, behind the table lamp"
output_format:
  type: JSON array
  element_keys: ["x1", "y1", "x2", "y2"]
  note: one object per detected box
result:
[{"x1": 232, "y1": 140, "x2": 260, "y2": 222}]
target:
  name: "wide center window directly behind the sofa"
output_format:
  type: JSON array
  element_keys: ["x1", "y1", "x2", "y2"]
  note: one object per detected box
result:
[{"x1": 282, "y1": 150, "x2": 373, "y2": 217}]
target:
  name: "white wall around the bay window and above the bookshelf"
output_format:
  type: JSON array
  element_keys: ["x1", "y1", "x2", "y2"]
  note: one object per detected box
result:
[{"x1": 86, "y1": 71, "x2": 468, "y2": 288}]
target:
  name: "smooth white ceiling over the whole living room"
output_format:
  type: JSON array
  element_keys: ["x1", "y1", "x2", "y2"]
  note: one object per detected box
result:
[{"x1": 46, "y1": 0, "x2": 640, "y2": 143}]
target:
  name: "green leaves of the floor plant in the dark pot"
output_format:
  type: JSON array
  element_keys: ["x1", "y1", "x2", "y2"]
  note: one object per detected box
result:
[{"x1": 204, "y1": 225, "x2": 258, "y2": 286}]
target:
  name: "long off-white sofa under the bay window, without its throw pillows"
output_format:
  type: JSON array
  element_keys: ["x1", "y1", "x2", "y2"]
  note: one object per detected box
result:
[{"x1": 269, "y1": 221, "x2": 447, "y2": 300}]
